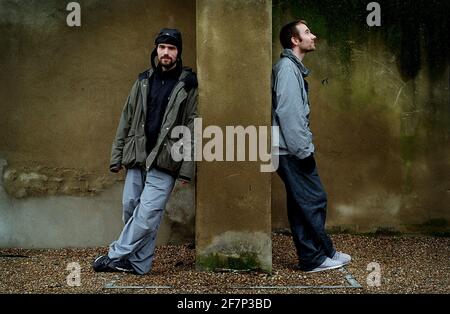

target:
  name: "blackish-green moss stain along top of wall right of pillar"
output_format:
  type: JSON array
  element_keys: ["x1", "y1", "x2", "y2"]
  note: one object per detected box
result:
[{"x1": 273, "y1": 0, "x2": 450, "y2": 81}]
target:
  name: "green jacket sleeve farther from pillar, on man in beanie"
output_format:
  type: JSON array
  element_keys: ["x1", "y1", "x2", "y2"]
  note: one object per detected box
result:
[{"x1": 109, "y1": 80, "x2": 139, "y2": 167}]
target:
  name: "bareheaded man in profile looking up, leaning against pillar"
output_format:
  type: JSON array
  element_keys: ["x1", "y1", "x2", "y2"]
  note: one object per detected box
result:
[{"x1": 272, "y1": 20, "x2": 351, "y2": 272}]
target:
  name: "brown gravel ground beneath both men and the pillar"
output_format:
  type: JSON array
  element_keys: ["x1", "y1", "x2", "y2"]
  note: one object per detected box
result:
[{"x1": 0, "y1": 234, "x2": 450, "y2": 294}]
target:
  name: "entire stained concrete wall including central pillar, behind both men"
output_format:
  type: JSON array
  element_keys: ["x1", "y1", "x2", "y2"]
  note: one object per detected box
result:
[{"x1": 0, "y1": 0, "x2": 450, "y2": 250}]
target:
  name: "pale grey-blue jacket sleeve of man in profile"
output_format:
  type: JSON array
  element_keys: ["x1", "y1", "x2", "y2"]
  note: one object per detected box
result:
[{"x1": 274, "y1": 65, "x2": 312, "y2": 159}]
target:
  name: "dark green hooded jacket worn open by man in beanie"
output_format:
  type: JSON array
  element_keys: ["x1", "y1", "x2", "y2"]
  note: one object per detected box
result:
[{"x1": 110, "y1": 67, "x2": 198, "y2": 181}]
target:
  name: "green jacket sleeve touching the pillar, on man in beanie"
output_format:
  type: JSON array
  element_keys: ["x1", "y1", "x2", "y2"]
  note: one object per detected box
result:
[{"x1": 179, "y1": 88, "x2": 198, "y2": 181}]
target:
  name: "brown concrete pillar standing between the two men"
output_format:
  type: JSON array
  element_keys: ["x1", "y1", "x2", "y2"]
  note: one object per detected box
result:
[{"x1": 196, "y1": 0, "x2": 272, "y2": 272}]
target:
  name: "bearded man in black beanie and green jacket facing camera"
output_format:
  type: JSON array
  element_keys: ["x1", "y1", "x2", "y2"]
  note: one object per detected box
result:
[{"x1": 92, "y1": 28, "x2": 198, "y2": 275}]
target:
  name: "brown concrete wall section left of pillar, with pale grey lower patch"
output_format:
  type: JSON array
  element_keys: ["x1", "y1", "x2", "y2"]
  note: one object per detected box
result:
[{"x1": 0, "y1": 0, "x2": 196, "y2": 247}]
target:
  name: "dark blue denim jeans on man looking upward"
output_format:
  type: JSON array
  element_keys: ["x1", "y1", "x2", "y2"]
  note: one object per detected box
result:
[{"x1": 277, "y1": 155, "x2": 336, "y2": 271}]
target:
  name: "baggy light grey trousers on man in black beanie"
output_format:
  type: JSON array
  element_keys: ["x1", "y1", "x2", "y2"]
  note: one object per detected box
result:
[{"x1": 108, "y1": 168, "x2": 175, "y2": 274}]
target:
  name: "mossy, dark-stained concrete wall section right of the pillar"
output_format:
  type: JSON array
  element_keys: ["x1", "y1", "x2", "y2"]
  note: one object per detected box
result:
[{"x1": 272, "y1": 0, "x2": 450, "y2": 235}]
